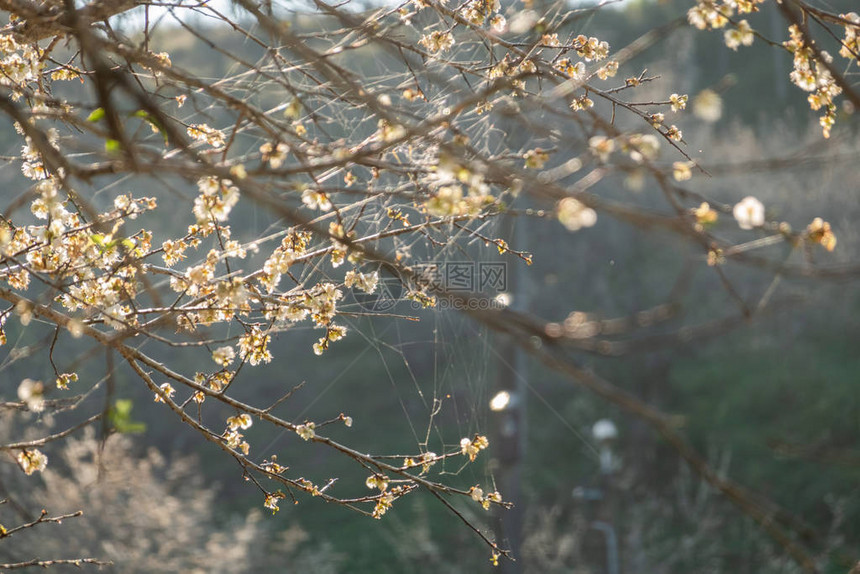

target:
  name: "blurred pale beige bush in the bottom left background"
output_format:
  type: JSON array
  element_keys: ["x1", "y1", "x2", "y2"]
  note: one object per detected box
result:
[{"x1": 2, "y1": 413, "x2": 337, "y2": 572}]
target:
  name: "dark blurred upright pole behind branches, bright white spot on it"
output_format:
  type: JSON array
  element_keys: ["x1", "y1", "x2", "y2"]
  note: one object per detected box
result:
[{"x1": 490, "y1": 215, "x2": 528, "y2": 574}]
